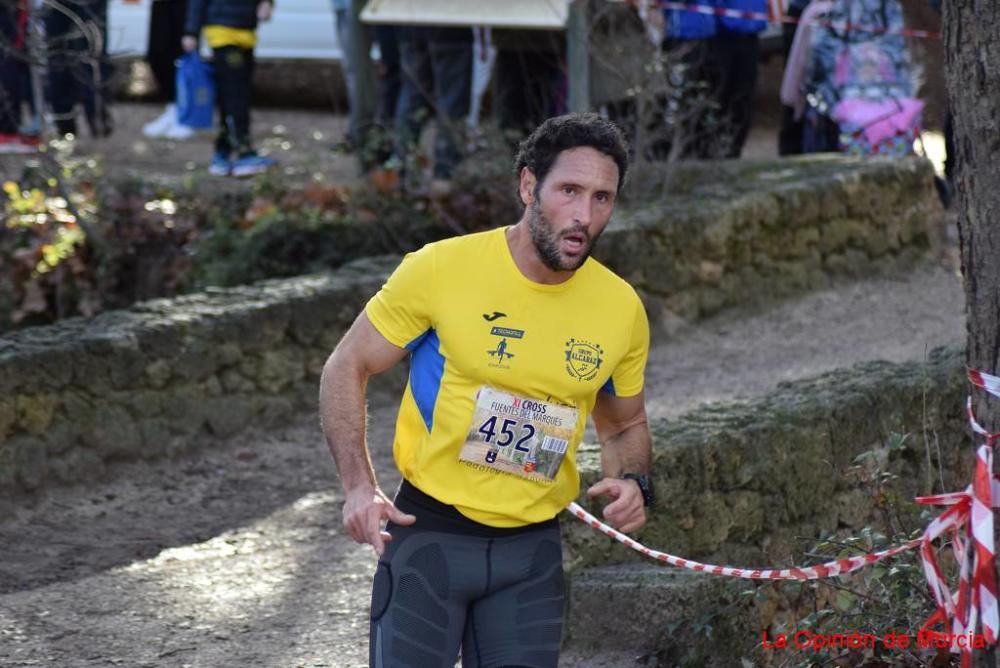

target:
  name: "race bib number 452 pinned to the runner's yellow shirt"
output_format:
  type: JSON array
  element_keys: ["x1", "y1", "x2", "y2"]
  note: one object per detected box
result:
[{"x1": 459, "y1": 387, "x2": 578, "y2": 482}]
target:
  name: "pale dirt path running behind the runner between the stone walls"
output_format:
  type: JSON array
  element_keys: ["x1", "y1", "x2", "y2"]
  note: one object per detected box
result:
[{"x1": 0, "y1": 258, "x2": 964, "y2": 668}]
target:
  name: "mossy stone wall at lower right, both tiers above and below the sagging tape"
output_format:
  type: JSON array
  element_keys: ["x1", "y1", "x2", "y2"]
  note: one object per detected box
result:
[{"x1": 563, "y1": 349, "x2": 975, "y2": 666}]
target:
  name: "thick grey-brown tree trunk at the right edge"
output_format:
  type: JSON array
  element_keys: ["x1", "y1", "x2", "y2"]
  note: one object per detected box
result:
[{"x1": 943, "y1": 0, "x2": 1000, "y2": 666}]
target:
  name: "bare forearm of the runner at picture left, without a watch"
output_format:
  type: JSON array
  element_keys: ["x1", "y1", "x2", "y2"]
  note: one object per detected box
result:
[{"x1": 319, "y1": 354, "x2": 378, "y2": 493}]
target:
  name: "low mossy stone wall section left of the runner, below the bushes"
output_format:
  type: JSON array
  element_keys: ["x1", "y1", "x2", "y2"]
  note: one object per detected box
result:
[{"x1": 0, "y1": 257, "x2": 398, "y2": 490}]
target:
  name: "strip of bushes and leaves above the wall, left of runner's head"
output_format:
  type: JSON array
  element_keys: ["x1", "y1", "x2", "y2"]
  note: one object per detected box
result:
[{"x1": 0, "y1": 138, "x2": 520, "y2": 332}]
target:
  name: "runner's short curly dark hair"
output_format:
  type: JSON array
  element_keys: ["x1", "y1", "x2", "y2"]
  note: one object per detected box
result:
[{"x1": 514, "y1": 113, "x2": 628, "y2": 193}]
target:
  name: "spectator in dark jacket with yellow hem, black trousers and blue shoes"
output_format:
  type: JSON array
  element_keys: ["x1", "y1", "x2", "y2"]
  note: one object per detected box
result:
[{"x1": 181, "y1": 0, "x2": 275, "y2": 176}]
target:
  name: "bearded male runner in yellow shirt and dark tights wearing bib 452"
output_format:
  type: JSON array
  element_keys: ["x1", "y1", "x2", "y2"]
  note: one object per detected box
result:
[{"x1": 320, "y1": 114, "x2": 652, "y2": 668}]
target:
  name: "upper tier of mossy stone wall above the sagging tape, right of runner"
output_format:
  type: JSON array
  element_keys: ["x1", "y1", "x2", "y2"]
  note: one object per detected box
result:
[{"x1": 564, "y1": 349, "x2": 974, "y2": 567}]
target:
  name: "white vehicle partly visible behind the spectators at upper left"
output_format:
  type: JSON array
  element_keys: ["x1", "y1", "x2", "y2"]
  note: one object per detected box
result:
[{"x1": 108, "y1": 0, "x2": 341, "y2": 60}]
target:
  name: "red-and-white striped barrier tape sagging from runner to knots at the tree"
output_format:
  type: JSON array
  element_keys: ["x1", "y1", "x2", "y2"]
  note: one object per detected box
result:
[{"x1": 566, "y1": 369, "x2": 1000, "y2": 668}]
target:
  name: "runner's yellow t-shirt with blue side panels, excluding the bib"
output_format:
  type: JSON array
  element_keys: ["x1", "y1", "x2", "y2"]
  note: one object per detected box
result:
[{"x1": 365, "y1": 224, "x2": 649, "y2": 527}]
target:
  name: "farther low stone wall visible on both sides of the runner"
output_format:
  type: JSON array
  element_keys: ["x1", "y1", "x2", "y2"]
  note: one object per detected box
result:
[{"x1": 0, "y1": 158, "x2": 940, "y2": 490}]
